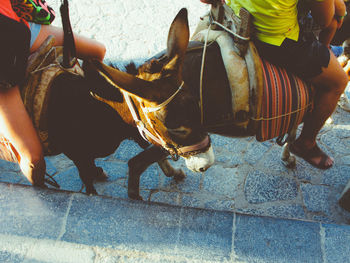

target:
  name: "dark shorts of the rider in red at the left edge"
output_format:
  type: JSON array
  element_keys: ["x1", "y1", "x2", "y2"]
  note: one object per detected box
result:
[{"x1": 0, "y1": 14, "x2": 30, "y2": 87}]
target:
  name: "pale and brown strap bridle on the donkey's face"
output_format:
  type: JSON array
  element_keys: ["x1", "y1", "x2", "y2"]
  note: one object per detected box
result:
[{"x1": 122, "y1": 81, "x2": 210, "y2": 161}]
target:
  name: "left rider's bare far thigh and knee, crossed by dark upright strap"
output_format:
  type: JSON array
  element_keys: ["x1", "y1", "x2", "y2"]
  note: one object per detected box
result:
[{"x1": 30, "y1": 25, "x2": 106, "y2": 61}]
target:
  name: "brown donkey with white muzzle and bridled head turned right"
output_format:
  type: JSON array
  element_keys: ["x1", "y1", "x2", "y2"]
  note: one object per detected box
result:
[{"x1": 0, "y1": 9, "x2": 214, "y2": 199}]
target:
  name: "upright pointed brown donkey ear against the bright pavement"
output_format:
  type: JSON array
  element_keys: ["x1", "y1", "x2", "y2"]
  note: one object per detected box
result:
[{"x1": 166, "y1": 8, "x2": 190, "y2": 74}]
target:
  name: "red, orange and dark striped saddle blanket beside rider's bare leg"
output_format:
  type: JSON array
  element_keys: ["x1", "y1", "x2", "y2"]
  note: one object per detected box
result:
[{"x1": 256, "y1": 59, "x2": 312, "y2": 141}]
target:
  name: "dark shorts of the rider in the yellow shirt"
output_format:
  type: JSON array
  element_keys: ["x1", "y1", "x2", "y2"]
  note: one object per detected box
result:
[{"x1": 255, "y1": 37, "x2": 330, "y2": 80}]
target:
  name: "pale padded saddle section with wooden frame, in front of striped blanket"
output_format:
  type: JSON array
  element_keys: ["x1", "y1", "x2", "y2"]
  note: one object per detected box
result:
[{"x1": 191, "y1": 5, "x2": 263, "y2": 133}]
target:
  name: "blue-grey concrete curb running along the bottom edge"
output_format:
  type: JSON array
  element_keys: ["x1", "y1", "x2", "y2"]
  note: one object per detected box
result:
[{"x1": 0, "y1": 183, "x2": 350, "y2": 263}]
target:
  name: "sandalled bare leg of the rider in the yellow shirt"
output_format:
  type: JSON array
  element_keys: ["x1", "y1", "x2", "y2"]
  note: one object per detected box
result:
[{"x1": 291, "y1": 53, "x2": 348, "y2": 169}]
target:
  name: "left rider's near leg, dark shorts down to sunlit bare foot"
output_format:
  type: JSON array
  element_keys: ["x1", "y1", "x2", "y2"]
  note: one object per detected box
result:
[{"x1": 0, "y1": 15, "x2": 45, "y2": 185}]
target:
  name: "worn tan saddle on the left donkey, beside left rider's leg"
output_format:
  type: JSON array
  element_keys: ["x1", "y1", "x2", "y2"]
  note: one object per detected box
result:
[{"x1": 21, "y1": 36, "x2": 84, "y2": 155}]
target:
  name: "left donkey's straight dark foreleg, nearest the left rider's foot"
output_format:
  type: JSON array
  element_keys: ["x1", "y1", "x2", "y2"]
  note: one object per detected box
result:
[{"x1": 73, "y1": 159, "x2": 98, "y2": 195}]
